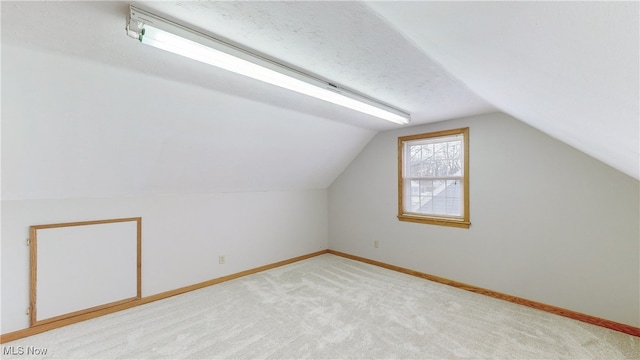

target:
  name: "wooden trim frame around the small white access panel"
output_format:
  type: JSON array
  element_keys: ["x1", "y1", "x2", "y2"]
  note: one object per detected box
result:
[{"x1": 29, "y1": 217, "x2": 142, "y2": 328}]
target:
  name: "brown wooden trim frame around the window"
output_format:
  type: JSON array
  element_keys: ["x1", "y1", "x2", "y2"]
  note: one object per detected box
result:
[{"x1": 398, "y1": 127, "x2": 471, "y2": 229}]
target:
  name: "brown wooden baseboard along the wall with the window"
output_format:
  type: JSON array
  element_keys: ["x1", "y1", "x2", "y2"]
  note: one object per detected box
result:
[{"x1": 327, "y1": 250, "x2": 640, "y2": 337}]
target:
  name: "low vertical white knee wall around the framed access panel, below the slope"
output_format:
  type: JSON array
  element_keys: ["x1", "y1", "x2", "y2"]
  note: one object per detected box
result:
[{"x1": 0, "y1": 190, "x2": 327, "y2": 333}]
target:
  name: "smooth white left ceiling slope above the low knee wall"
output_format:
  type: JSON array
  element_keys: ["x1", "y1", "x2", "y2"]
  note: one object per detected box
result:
[{"x1": 2, "y1": 46, "x2": 373, "y2": 200}]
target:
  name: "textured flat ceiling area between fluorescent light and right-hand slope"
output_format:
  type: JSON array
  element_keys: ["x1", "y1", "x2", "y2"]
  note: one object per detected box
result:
[{"x1": 139, "y1": 1, "x2": 496, "y2": 126}]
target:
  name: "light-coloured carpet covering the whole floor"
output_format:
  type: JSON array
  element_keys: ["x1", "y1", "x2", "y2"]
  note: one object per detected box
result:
[{"x1": 3, "y1": 254, "x2": 640, "y2": 359}]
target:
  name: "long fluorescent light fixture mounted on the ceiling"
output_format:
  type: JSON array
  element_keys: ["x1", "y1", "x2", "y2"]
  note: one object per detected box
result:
[{"x1": 127, "y1": 6, "x2": 411, "y2": 124}]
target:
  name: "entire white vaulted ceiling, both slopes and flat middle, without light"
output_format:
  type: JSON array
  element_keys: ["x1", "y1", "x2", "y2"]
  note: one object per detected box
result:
[{"x1": 0, "y1": 1, "x2": 640, "y2": 199}]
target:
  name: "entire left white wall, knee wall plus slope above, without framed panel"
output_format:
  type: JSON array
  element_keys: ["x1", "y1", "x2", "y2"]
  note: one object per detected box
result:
[{"x1": 0, "y1": 43, "x2": 348, "y2": 333}]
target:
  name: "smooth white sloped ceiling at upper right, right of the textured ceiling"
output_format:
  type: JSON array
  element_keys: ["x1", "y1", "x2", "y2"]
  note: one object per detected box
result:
[{"x1": 367, "y1": 1, "x2": 640, "y2": 181}]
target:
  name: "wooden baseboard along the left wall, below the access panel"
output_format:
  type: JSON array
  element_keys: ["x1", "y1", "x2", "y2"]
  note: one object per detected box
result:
[{"x1": 0, "y1": 250, "x2": 329, "y2": 344}]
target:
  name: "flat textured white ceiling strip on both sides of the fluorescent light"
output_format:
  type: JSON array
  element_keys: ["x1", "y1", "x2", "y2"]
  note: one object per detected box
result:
[{"x1": 2, "y1": 1, "x2": 497, "y2": 130}]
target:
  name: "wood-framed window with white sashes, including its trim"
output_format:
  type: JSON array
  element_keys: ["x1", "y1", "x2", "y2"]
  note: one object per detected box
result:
[{"x1": 398, "y1": 128, "x2": 471, "y2": 228}]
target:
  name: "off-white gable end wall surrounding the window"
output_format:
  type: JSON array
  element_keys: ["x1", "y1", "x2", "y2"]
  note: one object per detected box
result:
[{"x1": 329, "y1": 114, "x2": 640, "y2": 326}]
